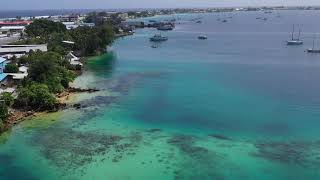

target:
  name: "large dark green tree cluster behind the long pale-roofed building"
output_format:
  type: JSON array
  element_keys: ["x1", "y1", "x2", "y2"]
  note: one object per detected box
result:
[{"x1": 21, "y1": 20, "x2": 114, "y2": 56}]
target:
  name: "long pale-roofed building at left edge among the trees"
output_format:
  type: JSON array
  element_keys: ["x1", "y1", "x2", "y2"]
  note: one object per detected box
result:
[{"x1": 0, "y1": 44, "x2": 48, "y2": 57}]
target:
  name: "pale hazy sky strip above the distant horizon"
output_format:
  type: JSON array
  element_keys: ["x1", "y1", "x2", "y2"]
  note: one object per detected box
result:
[{"x1": 0, "y1": 0, "x2": 320, "y2": 10}]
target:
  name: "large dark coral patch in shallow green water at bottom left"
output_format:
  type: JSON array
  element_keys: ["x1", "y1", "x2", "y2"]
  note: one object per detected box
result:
[{"x1": 33, "y1": 128, "x2": 142, "y2": 174}]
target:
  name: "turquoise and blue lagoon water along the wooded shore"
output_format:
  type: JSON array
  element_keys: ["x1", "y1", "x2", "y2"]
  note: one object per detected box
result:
[{"x1": 0, "y1": 11, "x2": 320, "y2": 180}]
